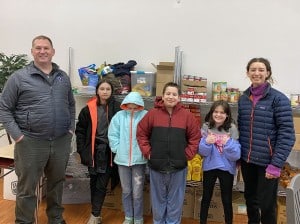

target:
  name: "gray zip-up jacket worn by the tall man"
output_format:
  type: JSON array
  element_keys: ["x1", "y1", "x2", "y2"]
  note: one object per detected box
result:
[{"x1": 0, "y1": 62, "x2": 75, "y2": 140}]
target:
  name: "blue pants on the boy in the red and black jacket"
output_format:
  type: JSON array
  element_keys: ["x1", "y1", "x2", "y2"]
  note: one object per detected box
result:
[{"x1": 150, "y1": 168, "x2": 187, "y2": 224}]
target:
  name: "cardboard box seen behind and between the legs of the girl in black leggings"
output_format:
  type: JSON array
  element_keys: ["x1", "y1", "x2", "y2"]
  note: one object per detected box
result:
[{"x1": 194, "y1": 187, "x2": 224, "y2": 223}]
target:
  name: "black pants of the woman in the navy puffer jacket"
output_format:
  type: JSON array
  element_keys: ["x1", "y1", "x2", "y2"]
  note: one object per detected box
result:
[{"x1": 241, "y1": 160, "x2": 278, "y2": 224}]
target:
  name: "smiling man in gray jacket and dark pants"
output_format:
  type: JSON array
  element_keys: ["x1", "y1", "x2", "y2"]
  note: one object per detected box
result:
[{"x1": 0, "y1": 36, "x2": 75, "y2": 224}]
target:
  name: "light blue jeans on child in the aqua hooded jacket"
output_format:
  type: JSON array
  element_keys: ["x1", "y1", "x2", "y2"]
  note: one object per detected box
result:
[{"x1": 118, "y1": 164, "x2": 146, "y2": 220}]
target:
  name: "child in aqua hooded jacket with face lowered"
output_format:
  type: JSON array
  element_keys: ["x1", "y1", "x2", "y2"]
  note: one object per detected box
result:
[{"x1": 108, "y1": 92, "x2": 147, "y2": 224}]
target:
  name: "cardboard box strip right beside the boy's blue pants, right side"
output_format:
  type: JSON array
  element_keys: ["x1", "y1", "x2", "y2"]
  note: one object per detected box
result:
[{"x1": 182, "y1": 187, "x2": 195, "y2": 218}]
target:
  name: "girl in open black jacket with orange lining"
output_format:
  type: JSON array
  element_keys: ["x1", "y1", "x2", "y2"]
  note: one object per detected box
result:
[{"x1": 75, "y1": 79, "x2": 120, "y2": 224}]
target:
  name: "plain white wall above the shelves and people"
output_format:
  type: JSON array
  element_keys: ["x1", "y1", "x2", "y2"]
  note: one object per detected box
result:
[{"x1": 0, "y1": 0, "x2": 300, "y2": 98}]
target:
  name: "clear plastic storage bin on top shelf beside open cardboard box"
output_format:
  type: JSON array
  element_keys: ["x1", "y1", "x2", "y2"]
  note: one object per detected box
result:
[{"x1": 131, "y1": 71, "x2": 155, "y2": 96}]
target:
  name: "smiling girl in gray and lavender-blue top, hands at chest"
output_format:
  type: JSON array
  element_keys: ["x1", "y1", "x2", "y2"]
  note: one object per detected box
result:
[{"x1": 199, "y1": 100, "x2": 241, "y2": 224}]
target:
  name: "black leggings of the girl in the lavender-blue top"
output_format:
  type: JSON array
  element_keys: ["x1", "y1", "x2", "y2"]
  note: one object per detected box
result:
[{"x1": 200, "y1": 169, "x2": 234, "y2": 224}]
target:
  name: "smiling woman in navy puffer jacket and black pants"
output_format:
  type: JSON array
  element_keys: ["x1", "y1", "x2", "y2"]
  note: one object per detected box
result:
[{"x1": 238, "y1": 58, "x2": 295, "y2": 224}]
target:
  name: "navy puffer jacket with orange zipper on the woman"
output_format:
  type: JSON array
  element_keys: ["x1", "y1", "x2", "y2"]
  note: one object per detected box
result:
[{"x1": 238, "y1": 85, "x2": 295, "y2": 168}]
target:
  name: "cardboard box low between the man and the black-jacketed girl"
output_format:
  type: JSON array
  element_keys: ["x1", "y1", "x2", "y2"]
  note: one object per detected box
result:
[{"x1": 62, "y1": 178, "x2": 91, "y2": 204}]
